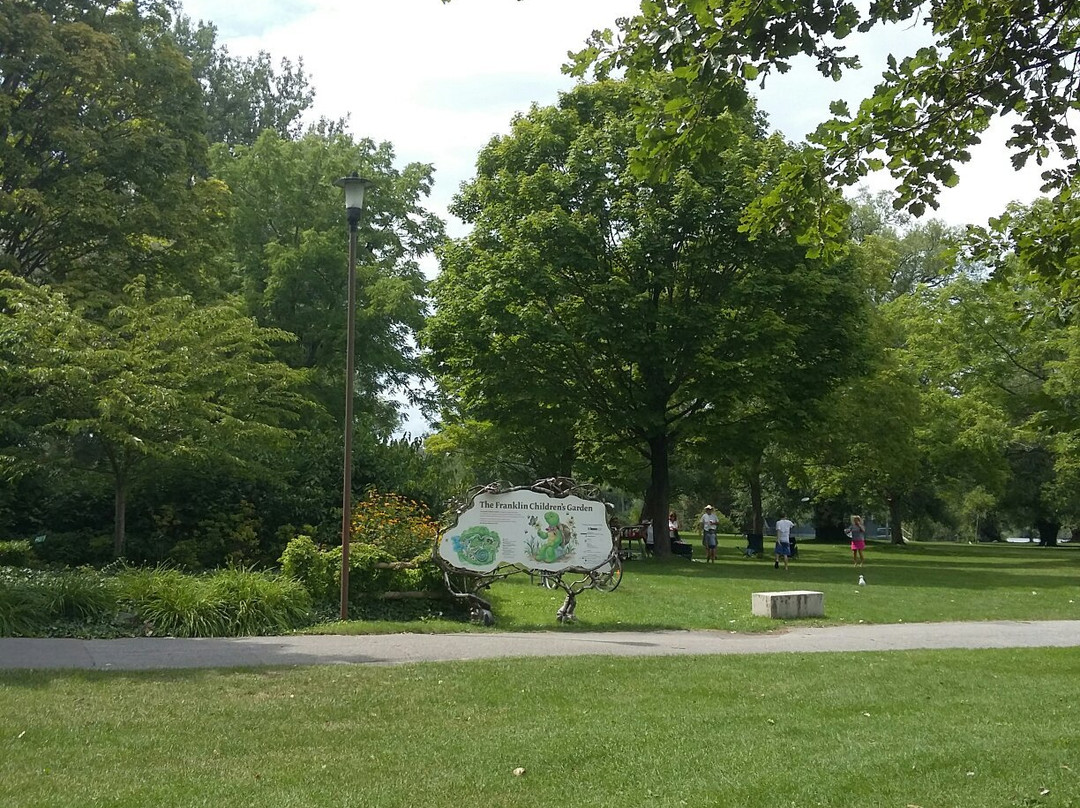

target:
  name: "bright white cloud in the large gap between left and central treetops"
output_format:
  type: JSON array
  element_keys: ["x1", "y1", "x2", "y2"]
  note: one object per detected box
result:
[{"x1": 184, "y1": 0, "x2": 637, "y2": 239}]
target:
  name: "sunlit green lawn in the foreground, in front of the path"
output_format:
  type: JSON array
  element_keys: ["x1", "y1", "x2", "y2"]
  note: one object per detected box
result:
[{"x1": 0, "y1": 649, "x2": 1080, "y2": 808}]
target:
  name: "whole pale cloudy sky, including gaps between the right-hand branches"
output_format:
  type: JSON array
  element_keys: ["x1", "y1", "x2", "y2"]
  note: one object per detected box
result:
[{"x1": 183, "y1": 0, "x2": 1058, "y2": 434}]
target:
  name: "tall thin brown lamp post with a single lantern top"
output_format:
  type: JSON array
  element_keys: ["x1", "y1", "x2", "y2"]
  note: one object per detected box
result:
[{"x1": 334, "y1": 172, "x2": 370, "y2": 620}]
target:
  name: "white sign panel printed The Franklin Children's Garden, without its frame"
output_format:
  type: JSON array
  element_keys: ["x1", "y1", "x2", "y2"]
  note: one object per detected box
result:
[{"x1": 438, "y1": 488, "x2": 612, "y2": 575}]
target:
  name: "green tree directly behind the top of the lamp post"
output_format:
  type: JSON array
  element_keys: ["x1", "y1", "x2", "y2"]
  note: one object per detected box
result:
[{"x1": 213, "y1": 129, "x2": 443, "y2": 436}]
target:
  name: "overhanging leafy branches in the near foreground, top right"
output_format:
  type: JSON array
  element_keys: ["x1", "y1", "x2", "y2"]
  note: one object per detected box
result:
[{"x1": 572, "y1": 0, "x2": 1080, "y2": 245}]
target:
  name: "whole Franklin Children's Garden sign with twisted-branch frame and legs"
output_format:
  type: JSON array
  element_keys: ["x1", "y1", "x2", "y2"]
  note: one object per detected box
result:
[{"x1": 433, "y1": 477, "x2": 622, "y2": 625}]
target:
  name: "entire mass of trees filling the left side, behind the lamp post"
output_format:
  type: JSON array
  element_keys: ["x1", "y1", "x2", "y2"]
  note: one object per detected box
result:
[{"x1": 0, "y1": 0, "x2": 446, "y2": 569}]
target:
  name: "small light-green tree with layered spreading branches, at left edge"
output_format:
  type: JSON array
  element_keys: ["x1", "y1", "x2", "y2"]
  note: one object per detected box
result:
[{"x1": 0, "y1": 273, "x2": 306, "y2": 556}]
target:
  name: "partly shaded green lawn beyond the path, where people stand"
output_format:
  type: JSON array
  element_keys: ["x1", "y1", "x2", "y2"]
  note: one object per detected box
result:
[{"x1": 315, "y1": 537, "x2": 1080, "y2": 633}]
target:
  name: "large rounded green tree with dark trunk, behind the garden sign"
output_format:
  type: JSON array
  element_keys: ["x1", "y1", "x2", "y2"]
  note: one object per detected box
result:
[{"x1": 424, "y1": 82, "x2": 861, "y2": 552}]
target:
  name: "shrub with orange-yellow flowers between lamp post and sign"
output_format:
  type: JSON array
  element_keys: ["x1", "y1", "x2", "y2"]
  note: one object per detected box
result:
[{"x1": 350, "y1": 488, "x2": 438, "y2": 566}]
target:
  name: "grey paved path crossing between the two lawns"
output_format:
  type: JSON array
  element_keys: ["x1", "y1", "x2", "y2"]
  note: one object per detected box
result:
[{"x1": 0, "y1": 620, "x2": 1080, "y2": 671}]
